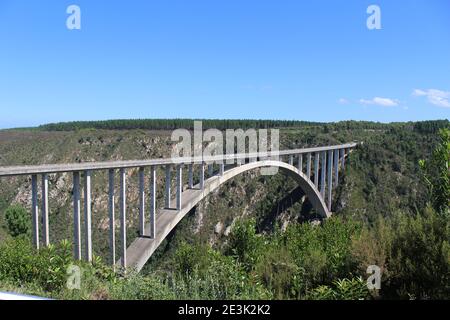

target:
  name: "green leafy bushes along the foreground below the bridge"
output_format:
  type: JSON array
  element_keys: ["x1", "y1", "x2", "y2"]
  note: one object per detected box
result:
[{"x1": 0, "y1": 209, "x2": 450, "y2": 299}]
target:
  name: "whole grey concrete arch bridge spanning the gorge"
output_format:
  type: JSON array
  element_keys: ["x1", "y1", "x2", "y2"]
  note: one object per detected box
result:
[{"x1": 0, "y1": 143, "x2": 357, "y2": 271}]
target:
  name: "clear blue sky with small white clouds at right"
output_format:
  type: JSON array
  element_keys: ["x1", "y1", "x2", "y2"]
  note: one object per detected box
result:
[{"x1": 0, "y1": 0, "x2": 450, "y2": 128}]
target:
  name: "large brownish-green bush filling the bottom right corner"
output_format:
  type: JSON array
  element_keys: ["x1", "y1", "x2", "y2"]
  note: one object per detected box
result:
[{"x1": 352, "y1": 208, "x2": 450, "y2": 299}]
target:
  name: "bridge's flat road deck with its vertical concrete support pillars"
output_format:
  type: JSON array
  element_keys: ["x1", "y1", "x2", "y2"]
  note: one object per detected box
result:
[{"x1": 0, "y1": 142, "x2": 357, "y2": 266}]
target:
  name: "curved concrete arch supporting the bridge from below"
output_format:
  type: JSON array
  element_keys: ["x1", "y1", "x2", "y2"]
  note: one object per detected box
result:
[{"x1": 123, "y1": 160, "x2": 331, "y2": 271}]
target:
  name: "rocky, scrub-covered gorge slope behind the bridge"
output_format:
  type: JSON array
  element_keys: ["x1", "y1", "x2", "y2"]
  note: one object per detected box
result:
[{"x1": 0, "y1": 126, "x2": 435, "y2": 263}]
